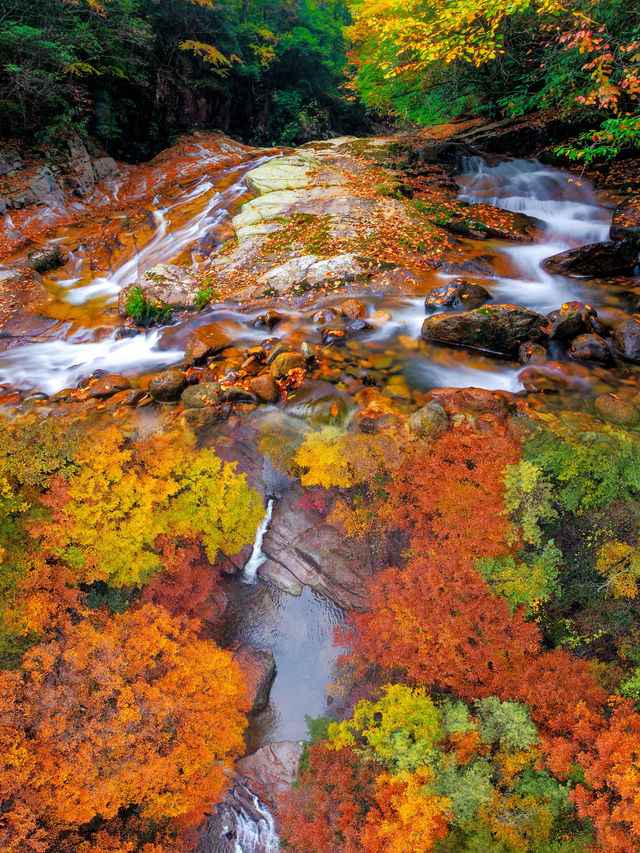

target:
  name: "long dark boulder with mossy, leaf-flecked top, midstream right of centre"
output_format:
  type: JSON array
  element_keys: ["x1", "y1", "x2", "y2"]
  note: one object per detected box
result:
[{"x1": 422, "y1": 305, "x2": 548, "y2": 357}]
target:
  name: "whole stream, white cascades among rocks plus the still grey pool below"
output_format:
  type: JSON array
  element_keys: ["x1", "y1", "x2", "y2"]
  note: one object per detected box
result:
[{"x1": 0, "y1": 140, "x2": 628, "y2": 853}]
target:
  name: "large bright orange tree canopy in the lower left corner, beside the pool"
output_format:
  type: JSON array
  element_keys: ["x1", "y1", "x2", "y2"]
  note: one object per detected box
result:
[{"x1": 0, "y1": 604, "x2": 248, "y2": 853}]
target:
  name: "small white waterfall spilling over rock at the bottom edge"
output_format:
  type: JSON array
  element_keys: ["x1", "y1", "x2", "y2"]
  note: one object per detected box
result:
[{"x1": 198, "y1": 780, "x2": 280, "y2": 853}]
